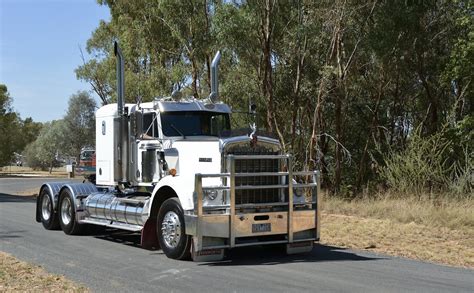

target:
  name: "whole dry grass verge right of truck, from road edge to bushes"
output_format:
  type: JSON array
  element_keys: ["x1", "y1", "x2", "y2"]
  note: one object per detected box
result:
[{"x1": 321, "y1": 193, "x2": 474, "y2": 268}]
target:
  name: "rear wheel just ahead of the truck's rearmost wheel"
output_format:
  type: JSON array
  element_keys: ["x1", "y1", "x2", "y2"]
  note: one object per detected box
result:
[{"x1": 58, "y1": 189, "x2": 85, "y2": 235}]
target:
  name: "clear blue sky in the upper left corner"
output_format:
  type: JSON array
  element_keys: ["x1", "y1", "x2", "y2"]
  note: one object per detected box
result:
[{"x1": 0, "y1": 0, "x2": 110, "y2": 122}]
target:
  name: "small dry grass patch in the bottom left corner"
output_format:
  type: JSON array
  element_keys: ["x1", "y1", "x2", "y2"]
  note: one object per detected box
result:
[{"x1": 0, "y1": 251, "x2": 89, "y2": 292}]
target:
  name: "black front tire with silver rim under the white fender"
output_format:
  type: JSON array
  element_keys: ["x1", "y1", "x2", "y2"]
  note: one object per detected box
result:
[{"x1": 156, "y1": 197, "x2": 191, "y2": 259}]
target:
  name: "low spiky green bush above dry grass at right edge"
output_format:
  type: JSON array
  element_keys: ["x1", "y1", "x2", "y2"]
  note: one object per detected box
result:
[{"x1": 380, "y1": 117, "x2": 474, "y2": 197}]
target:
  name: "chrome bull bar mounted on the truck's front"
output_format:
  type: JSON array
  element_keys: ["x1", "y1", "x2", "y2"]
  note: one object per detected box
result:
[{"x1": 185, "y1": 155, "x2": 320, "y2": 251}]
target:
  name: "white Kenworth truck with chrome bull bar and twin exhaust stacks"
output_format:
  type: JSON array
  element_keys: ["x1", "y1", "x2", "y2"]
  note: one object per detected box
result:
[{"x1": 36, "y1": 43, "x2": 320, "y2": 261}]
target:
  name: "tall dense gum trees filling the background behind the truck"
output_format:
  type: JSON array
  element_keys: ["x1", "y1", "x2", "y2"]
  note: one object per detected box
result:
[{"x1": 76, "y1": 0, "x2": 474, "y2": 194}]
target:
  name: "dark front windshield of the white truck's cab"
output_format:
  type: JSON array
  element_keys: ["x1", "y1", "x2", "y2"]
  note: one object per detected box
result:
[{"x1": 160, "y1": 111, "x2": 230, "y2": 136}]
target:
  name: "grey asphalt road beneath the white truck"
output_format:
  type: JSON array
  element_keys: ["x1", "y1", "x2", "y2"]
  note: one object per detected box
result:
[{"x1": 0, "y1": 178, "x2": 474, "y2": 292}]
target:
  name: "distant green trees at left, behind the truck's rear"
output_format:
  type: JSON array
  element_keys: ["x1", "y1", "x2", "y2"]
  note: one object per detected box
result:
[{"x1": 0, "y1": 84, "x2": 96, "y2": 174}]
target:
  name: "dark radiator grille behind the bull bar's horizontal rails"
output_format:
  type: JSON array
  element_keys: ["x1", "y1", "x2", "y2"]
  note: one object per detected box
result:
[{"x1": 227, "y1": 148, "x2": 280, "y2": 205}]
